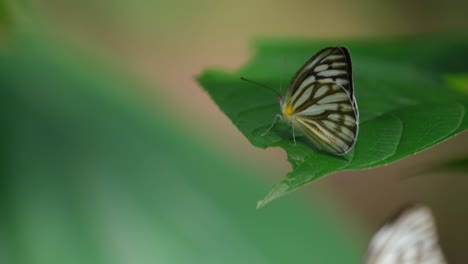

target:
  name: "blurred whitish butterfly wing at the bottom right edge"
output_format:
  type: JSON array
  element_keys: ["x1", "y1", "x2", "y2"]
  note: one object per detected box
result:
[{"x1": 365, "y1": 205, "x2": 447, "y2": 264}]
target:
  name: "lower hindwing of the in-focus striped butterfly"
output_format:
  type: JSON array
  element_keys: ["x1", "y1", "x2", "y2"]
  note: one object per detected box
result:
[{"x1": 290, "y1": 81, "x2": 358, "y2": 155}]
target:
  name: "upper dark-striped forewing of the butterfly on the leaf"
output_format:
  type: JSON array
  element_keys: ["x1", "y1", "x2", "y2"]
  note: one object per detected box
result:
[{"x1": 286, "y1": 47, "x2": 355, "y2": 105}]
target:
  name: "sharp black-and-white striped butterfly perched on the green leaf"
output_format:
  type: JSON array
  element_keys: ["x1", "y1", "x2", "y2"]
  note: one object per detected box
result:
[{"x1": 241, "y1": 47, "x2": 359, "y2": 155}]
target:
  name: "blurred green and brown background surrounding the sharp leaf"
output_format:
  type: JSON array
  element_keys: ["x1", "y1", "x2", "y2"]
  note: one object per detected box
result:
[{"x1": 0, "y1": 0, "x2": 468, "y2": 263}]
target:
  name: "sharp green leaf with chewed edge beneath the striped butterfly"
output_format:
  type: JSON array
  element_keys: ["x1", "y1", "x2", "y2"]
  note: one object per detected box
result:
[{"x1": 198, "y1": 35, "x2": 468, "y2": 207}]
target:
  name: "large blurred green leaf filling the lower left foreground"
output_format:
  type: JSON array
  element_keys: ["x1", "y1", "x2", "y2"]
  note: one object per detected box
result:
[{"x1": 0, "y1": 37, "x2": 360, "y2": 264}]
